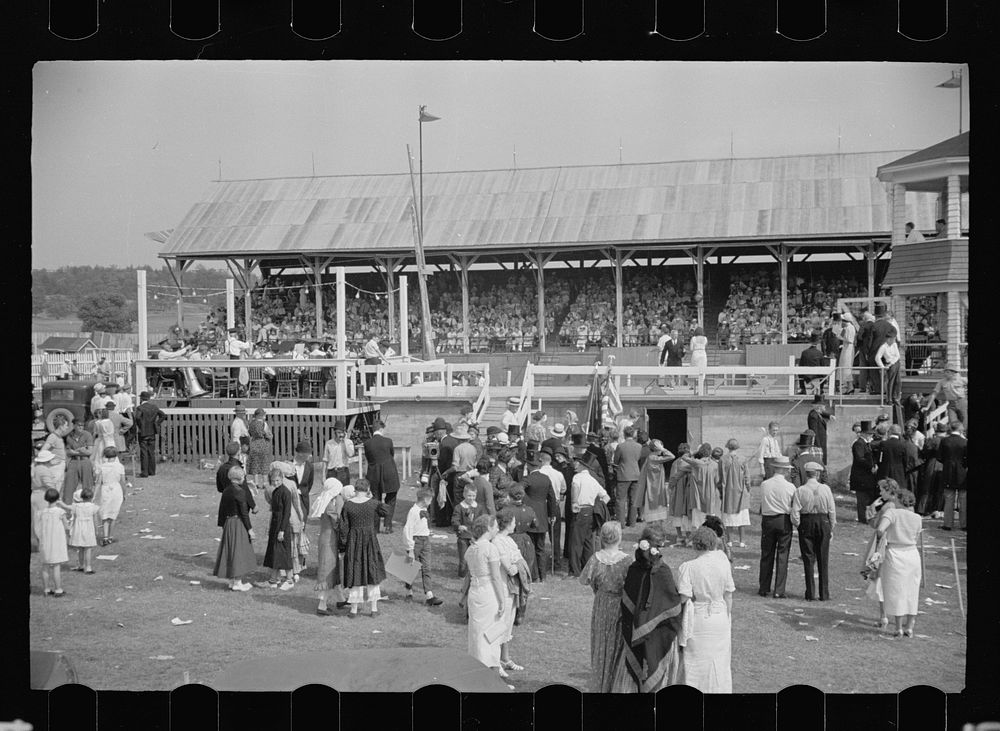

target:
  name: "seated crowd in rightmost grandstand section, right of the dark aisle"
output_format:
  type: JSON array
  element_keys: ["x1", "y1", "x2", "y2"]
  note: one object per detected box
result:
[{"x1": 717, "y1": 266, "x2": 866, "y2": 350}]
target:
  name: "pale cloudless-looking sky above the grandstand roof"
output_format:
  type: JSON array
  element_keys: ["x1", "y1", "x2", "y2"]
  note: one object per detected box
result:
[{"x1": 32, "y1": 61, "x2": 969, "y2": 268}]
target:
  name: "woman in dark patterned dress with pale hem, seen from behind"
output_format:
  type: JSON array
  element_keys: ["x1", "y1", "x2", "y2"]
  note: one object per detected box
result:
[{"x1": 339, "y1": 477, "x2": 389, "y2": 619}]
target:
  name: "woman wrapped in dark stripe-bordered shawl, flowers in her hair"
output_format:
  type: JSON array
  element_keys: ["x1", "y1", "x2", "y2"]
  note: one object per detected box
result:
[{"x1": 622, "y1": 523, "x2": 682, "y2": 693}]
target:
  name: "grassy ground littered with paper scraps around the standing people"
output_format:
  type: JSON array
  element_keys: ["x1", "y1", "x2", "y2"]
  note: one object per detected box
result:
[{"x1": 30, "y1": 464, "x2": 966, "y2": 693}]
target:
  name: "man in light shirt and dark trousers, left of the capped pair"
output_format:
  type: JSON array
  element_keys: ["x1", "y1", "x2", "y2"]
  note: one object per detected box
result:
[{"x1": 757, "y1": 457, "x2": 795, "y2": 599}]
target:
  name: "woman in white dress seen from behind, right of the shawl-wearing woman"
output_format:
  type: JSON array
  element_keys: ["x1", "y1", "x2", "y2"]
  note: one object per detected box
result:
[{"x1": 677, "y1": 526, "x2": 736, "y2": 693}]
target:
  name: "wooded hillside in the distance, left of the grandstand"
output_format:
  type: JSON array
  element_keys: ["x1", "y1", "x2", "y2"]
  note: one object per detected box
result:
[{"x1": 31, "y1": 265, "x2": 228, "y2": 332}]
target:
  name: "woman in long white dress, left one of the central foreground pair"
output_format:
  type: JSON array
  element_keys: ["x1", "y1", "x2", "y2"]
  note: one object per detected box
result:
[{"x1": 465, "y1": 514, "x2": 507, "y2": 678}]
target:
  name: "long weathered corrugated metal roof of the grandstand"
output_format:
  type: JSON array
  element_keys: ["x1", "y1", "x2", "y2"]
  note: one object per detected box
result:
[{"x1": 160, "y1": 151, "x2": 936, "y2": 258}]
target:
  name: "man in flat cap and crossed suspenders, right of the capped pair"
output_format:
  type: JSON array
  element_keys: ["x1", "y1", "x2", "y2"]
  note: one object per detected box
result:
[{"x1": 792, "y1": 462, "x2": 837, "y2": 602}]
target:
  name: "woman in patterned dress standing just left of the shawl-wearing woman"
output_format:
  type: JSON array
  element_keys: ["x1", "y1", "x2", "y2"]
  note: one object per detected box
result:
[{"x1": 580, "y1": 520, "x2": 632, "y2": 693}]
